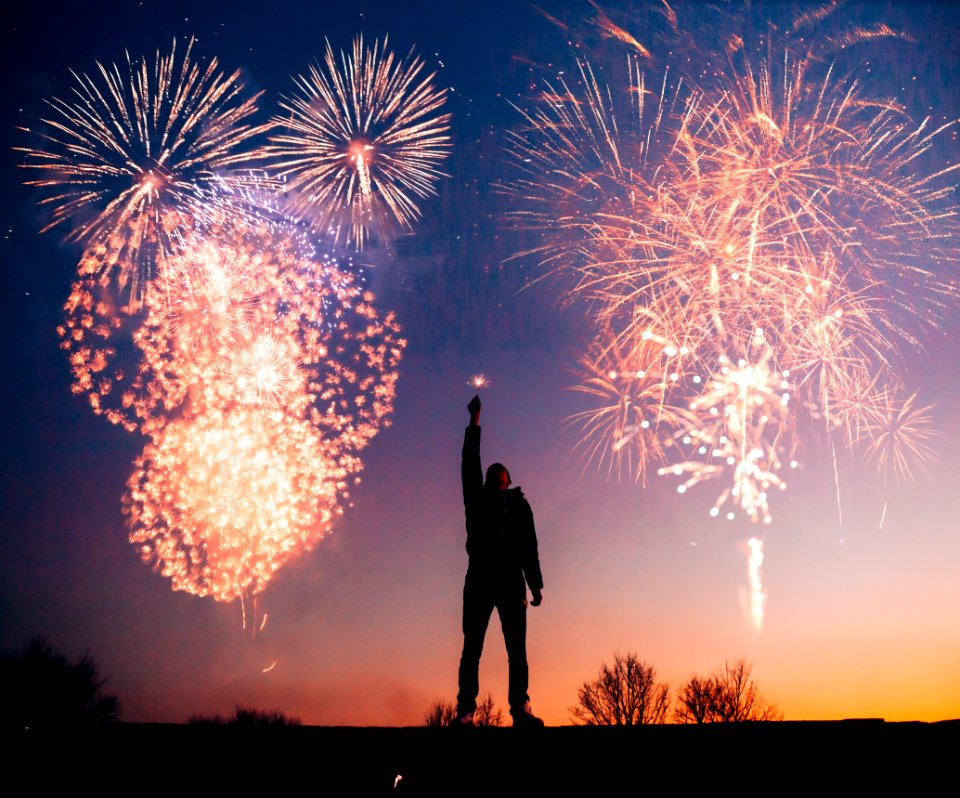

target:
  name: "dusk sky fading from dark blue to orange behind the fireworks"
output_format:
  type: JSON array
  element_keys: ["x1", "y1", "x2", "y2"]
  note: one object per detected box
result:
[{"x1": 0, "y1": 0, "x2": 960, "y2": 725}]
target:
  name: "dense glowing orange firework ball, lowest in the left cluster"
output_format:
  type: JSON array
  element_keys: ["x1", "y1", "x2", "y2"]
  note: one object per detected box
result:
[{"x1": 124, "y1": 406, "x2": 345, "y2": 601}]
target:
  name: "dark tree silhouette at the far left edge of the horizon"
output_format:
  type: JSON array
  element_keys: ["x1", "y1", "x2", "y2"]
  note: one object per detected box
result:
[{"x1": 0, "y1": 637, "x2": 120, "y2": 731}]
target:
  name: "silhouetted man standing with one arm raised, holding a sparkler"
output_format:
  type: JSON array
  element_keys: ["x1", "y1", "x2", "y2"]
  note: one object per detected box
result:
[{"x1": 454, "y1": 396, "x2": 543, "y2": 727}]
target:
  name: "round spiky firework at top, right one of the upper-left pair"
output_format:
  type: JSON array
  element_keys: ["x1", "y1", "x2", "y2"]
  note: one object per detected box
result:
[{"x1": 263, "y1": 36, "x2": 450, "y2": 249}]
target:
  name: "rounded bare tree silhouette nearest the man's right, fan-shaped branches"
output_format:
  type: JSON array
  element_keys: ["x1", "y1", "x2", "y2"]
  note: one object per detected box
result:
[{"x1": 570, "y1": 653, "x2": 670, "y2": 726}]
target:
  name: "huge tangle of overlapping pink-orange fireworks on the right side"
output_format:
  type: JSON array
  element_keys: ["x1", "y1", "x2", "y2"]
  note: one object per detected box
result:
[{"x1": 505, "y1": 6, "x2": 958, "y2": 523}]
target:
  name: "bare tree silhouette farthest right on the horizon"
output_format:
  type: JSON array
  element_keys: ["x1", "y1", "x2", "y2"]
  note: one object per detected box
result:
[{"x1": 673, "y1": 659, "x2": 783, "y2": 723}]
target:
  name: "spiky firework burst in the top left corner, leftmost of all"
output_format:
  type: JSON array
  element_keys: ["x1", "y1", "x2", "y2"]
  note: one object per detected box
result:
[{"x1": 17, "y1": 39, "x2": 265, "y2": 300}]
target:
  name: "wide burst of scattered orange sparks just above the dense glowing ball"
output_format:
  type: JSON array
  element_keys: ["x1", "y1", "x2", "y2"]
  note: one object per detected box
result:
[{"x1": 60, "y1": 223, "x2": 405, "y2": 444}]
